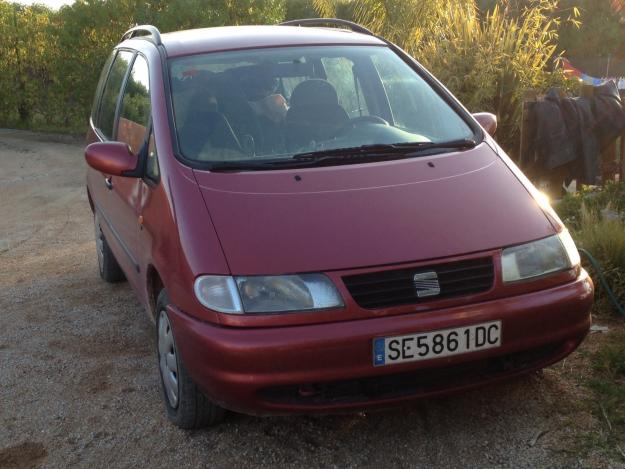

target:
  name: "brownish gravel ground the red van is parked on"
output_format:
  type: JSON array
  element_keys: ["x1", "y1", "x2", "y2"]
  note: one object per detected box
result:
[{"x1": 0, "y1": 130, "x2": 625, "y2": 468}]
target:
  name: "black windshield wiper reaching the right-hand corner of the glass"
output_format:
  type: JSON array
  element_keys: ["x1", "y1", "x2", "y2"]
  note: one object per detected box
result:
[{"x1": 293, "y1": 139, "x2": 477, "y2": 161}]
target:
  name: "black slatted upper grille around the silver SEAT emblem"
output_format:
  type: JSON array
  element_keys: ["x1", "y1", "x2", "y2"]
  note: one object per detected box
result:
[{"x1": 343, "y1": 257, "x2": 494, "y2": 309}]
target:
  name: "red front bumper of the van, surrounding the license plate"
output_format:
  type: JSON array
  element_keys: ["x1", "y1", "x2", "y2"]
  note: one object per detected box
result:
[{"x1": 169, "y1": 270, "x2": 593, "y2": 414}]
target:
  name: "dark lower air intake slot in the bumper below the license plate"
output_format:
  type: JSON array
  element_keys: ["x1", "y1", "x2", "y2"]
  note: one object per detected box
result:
[{"x1": 259, "y1": 343, "x2": 564, "y2": 406}]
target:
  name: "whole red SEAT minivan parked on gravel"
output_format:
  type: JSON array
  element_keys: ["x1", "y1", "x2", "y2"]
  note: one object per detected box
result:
[{"x1": 85, "y1": 19, "x2": 593, "y2": 428}]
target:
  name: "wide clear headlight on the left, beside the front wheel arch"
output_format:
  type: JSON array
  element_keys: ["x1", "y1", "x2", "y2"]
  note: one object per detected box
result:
[{"x1": 194, "y1": 274, "x2": 343, "y2": 314}]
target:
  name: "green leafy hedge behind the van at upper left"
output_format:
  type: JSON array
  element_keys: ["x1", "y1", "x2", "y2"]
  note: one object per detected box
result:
[{"x1": 0, "y1": 0, "x2": 285, "y2": 133}]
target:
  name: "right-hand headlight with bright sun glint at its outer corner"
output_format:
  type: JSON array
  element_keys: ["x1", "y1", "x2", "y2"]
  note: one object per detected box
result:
[{"x1": 501, "y1": 230, "x2": 580, "y2": 282}]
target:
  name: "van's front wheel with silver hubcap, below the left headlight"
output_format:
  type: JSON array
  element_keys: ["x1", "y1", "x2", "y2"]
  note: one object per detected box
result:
[{"x1": 156, "y1": 290, "x2": 226, "y2": 429}]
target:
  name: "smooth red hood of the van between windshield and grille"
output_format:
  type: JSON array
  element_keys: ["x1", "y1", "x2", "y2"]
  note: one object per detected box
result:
[{"x1": 194, "y1": 143, "x2": 555, "y2": 275}]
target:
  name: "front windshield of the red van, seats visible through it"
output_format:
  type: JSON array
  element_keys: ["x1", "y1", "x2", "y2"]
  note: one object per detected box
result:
[{"x1": 170, "y1": 46, "x2": 475, "y2": 163}]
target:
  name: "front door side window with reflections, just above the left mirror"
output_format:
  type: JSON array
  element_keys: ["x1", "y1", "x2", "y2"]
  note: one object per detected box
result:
[{"x1": 116, "y1": 55, "x2": 150, "y2": 155}]
